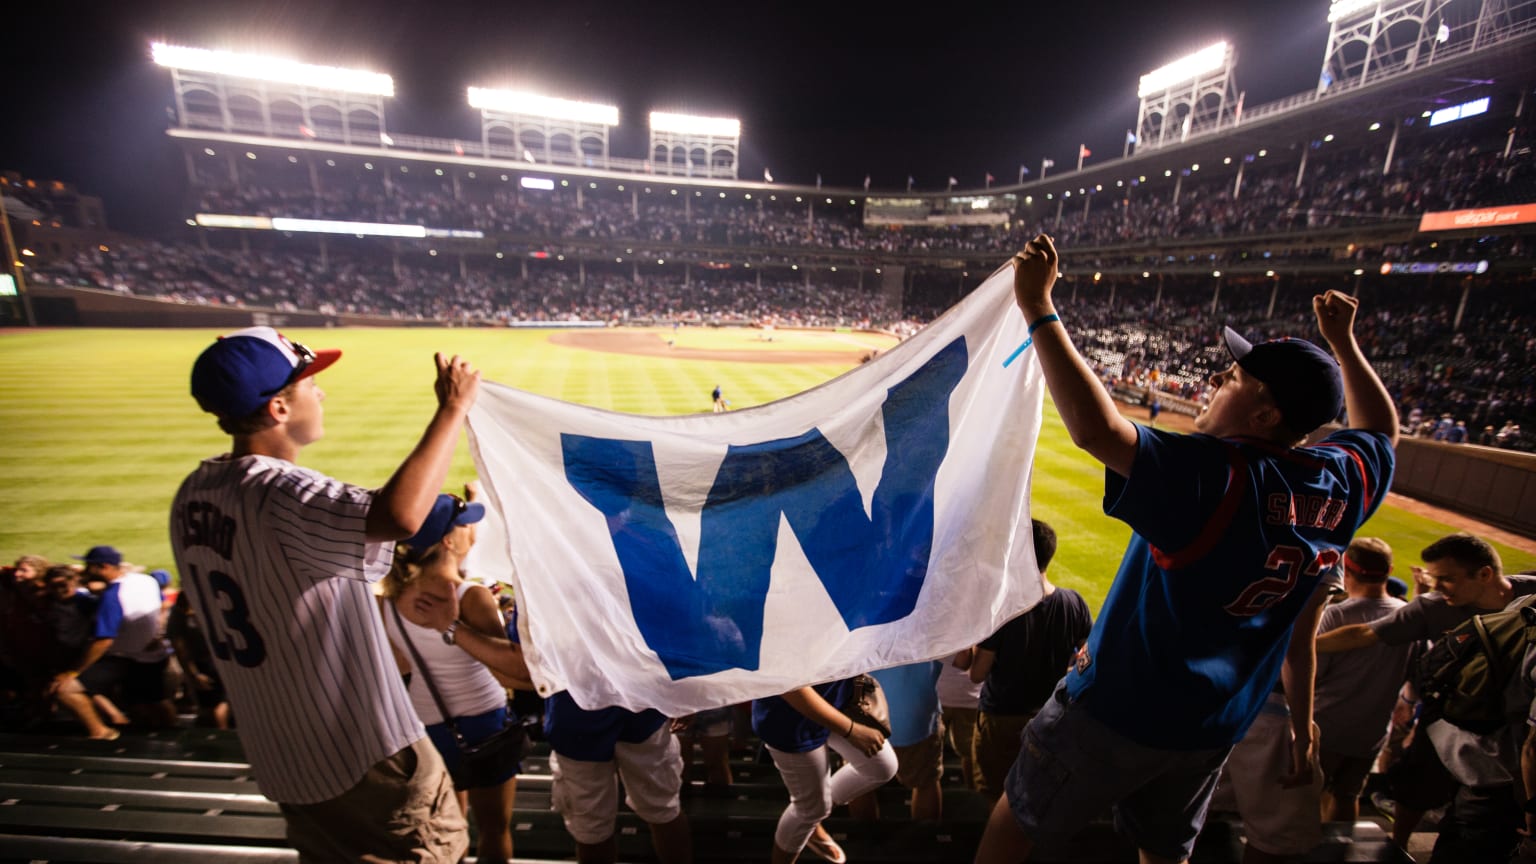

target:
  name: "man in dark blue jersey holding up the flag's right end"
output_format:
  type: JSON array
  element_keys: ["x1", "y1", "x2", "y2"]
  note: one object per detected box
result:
[{"x1": 977, "y1": 235, "x2": 1398, "y2": 862}]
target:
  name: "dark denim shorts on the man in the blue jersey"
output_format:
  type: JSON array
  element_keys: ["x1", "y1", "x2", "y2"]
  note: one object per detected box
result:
[{"x1": 1006, "y1": 686, "x2": 1232, "y2": 861}]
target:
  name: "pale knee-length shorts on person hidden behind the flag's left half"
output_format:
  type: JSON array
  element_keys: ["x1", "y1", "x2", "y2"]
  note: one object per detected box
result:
[{"x1": 550, "y1": 723, "x2": 682, "y2": 846}]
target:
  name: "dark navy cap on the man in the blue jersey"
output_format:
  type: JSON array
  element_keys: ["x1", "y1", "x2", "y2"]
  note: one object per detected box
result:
[{"x1": 1223, "y1": 327, "x2": 1344, "y2": 435}]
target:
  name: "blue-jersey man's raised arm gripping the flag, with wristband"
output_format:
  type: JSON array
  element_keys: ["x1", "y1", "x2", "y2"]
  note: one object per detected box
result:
[{"x1": 1014, "y1": 234, "x2": 1137, "y2": 477}]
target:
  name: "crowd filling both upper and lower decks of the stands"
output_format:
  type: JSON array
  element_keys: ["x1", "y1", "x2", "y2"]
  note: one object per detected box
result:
[{"x1": 21, "y1": 106, "x2": 1536, "y2": 449}]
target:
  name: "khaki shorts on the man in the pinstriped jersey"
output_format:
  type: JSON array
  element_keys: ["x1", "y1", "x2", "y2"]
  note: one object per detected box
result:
[{"x1": 278, "y1": 738, "x2": 470, "y2": 864}]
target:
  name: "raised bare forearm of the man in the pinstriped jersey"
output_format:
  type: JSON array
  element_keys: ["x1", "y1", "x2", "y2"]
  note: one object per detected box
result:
[{"x1": 367, "y1": 354, "x2": 479, "y2": 543}]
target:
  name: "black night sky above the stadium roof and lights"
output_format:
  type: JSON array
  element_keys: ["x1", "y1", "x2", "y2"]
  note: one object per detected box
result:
[{"x1": 0, "y1": 0, "x2": 1329, "y2": 232}]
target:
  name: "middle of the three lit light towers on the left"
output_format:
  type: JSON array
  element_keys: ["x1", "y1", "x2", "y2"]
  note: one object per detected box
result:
[{"x1": 468, "y1": 88, "x2": 619, "y2": 166}]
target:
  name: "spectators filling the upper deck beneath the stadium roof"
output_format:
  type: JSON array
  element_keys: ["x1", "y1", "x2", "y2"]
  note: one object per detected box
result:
[{"x1": 185, "y1": 116, "x2": 1536, "y2": 262}]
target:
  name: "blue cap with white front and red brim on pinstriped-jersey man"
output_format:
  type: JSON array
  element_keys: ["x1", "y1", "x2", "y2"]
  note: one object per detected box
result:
[{"x1": 192, "y1": 327, "x2": 341, "y2": 418}]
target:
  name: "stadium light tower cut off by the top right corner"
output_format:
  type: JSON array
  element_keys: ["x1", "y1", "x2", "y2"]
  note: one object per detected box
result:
[{"x1": 1318, "y1": 0, "x2": 1499, "y2": 95}]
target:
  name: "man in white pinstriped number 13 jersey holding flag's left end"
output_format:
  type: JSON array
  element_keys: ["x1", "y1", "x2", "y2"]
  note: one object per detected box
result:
[{"x1": 170, "y1": 327, "x2": 479, "y2": 862}]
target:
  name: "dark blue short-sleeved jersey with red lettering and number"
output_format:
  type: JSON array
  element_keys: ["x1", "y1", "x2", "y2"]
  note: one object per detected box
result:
[{"x1": 1066, "y1": 426, "x2": 1395, "y2": 750}]
